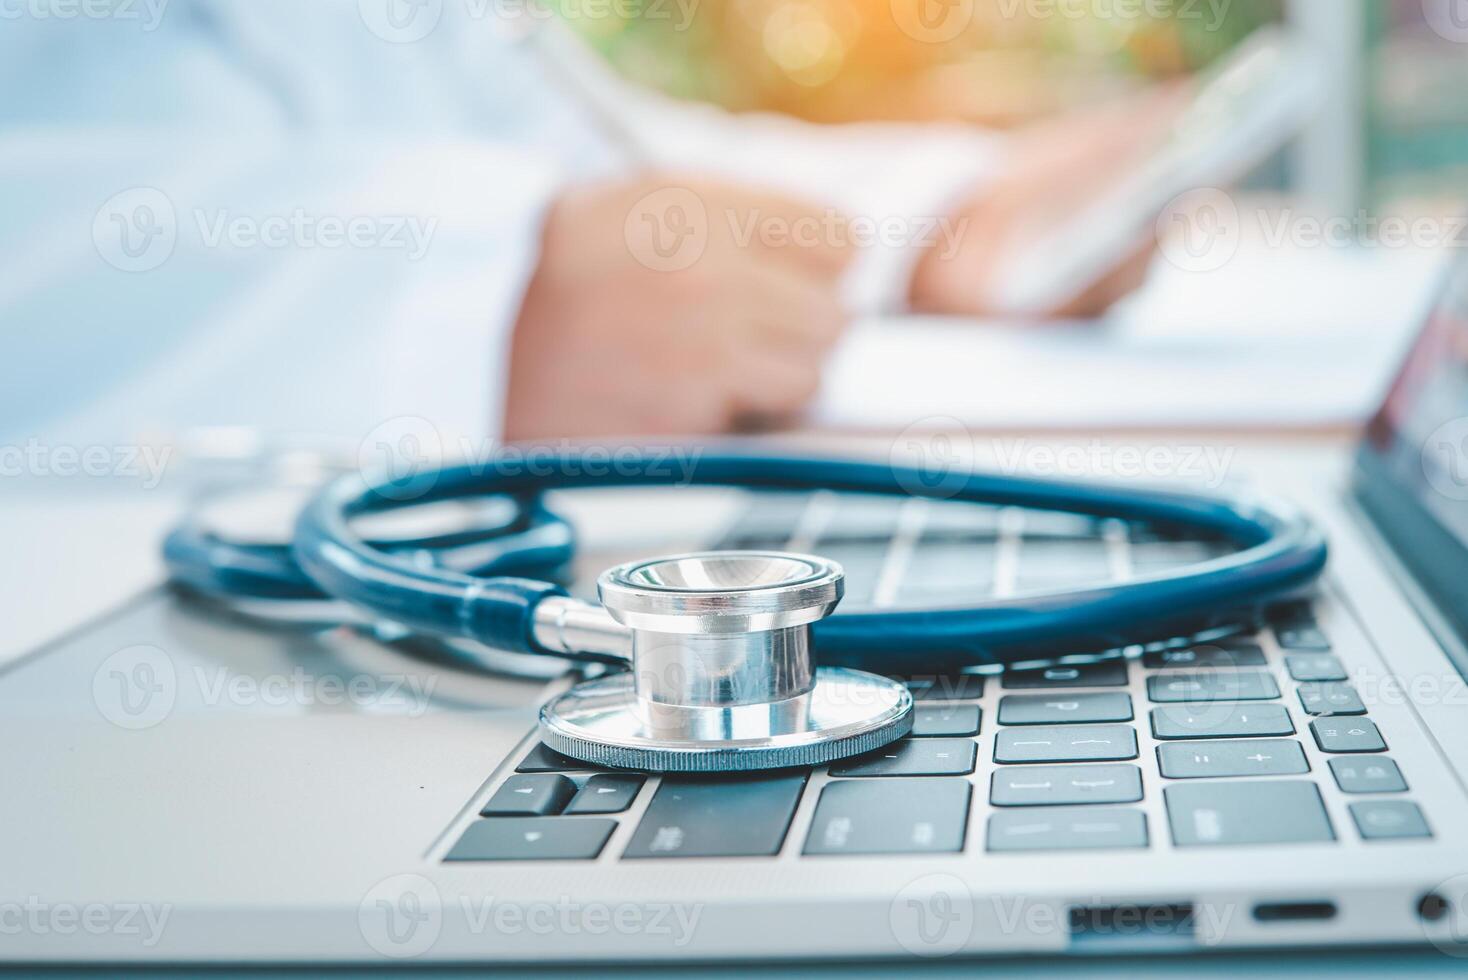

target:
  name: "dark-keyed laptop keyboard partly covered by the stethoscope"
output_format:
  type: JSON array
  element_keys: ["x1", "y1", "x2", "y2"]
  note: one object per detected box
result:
[{"x1": 445, "y1": 494, "x2": 1431, "y2": 861}]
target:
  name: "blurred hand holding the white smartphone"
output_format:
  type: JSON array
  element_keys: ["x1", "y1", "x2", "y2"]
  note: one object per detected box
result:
[{"x1": 910, "y1": 87, "x2": 1186, "y2": 318}]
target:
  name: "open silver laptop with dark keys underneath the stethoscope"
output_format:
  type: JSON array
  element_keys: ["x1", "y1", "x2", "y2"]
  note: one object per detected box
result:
[{"x1": 0, "y1": 261, "x2": 1468, "y2": 964}]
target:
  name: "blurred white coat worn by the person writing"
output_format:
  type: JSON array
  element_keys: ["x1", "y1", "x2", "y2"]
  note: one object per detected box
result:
[{"x1": 0, "y1": 0, "x2": 988, "y2": 447}]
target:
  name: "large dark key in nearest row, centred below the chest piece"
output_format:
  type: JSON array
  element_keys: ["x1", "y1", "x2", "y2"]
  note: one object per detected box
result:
[{"x1": 622, "y1": 775, "x2": 806, "y2": 858}]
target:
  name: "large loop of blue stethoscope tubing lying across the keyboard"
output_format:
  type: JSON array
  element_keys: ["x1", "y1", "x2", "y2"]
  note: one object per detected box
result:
[{"x1": 294, "y1": 453, "x2": 1327, "y2": 673}]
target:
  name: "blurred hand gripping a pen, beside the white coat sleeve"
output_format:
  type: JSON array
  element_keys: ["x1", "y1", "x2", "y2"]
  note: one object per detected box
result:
[{"x1": 505, "y1": 175, "x2": 850, "y2": 440}]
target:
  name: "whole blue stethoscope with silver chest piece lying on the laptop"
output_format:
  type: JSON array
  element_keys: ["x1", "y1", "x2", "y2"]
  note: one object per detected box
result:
[{"x1": 164, "y1": 452, "x2": 1327, "y2": 772}]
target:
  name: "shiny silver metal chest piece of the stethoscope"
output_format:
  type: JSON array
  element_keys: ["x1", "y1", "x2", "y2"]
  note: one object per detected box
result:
[{"x1": 540, "y1": 552, "x2": 913, "y2": 772}]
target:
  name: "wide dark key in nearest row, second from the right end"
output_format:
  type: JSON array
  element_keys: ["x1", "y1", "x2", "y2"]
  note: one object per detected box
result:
[{"x1": 1163, "y1": 779, "x2": 1336, "y2": 846}]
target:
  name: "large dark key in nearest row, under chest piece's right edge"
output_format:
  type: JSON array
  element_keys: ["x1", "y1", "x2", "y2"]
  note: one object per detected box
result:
[{"x1": 804, "y1": 779, "x2": 969, "y2": 854}]
